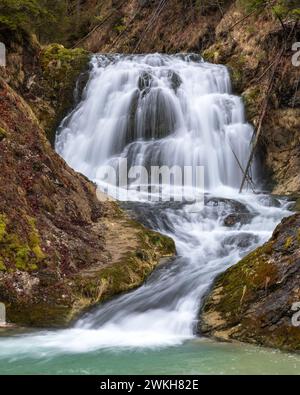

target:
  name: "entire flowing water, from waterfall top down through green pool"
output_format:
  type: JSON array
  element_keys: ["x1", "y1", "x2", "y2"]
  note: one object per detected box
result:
[{"x1": 0, "y1": 54, "x2": 300, "y2": 374}]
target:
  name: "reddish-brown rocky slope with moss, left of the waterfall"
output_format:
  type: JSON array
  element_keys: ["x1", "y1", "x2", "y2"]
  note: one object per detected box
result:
[{"x1": 0, "y1": 38, "x2": 175, "y2": 327}]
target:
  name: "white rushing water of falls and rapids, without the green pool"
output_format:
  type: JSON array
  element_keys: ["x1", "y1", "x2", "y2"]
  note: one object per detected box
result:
[{"x1": 0, "y1": 55, "x2": 289, "y2": 357}]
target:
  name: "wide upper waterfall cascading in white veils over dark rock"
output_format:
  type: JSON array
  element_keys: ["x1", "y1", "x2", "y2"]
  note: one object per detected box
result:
[{"x1": 56, "y1": 54, "x2": 252, "y2": 190}]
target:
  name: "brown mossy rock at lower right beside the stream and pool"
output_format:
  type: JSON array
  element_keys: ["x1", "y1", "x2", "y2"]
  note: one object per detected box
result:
[{"x1": 199, "y1": 214, "x2": 300, "y2": 351}]
